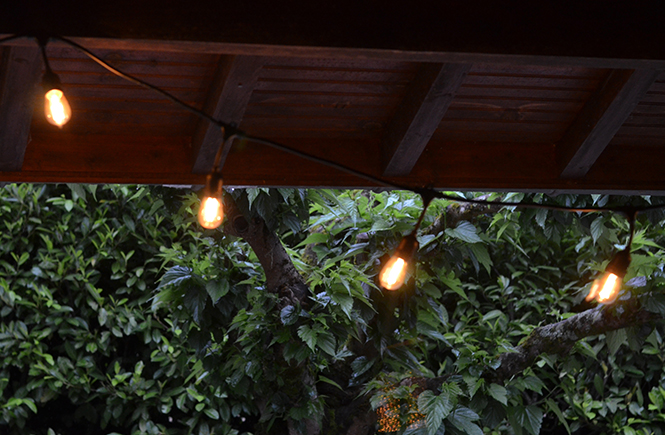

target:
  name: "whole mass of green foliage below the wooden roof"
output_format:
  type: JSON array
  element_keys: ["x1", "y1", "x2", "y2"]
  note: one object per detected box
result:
[{"x1": 0, "y1": 185, "x2": 665, "y2": 435}]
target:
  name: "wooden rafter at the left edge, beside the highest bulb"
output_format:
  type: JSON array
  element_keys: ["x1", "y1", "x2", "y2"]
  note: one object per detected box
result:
[{"x1": 0, "y1": 47, "x2": 42, "y2": 171}]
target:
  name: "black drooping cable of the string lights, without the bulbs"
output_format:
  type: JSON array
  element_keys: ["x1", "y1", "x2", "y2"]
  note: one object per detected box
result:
[{"x1": 19, "y1": 36, "x2": 665, "y2": 218}]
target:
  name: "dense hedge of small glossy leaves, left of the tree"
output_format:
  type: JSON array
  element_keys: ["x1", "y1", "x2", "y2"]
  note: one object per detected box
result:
[{"x1": 0, "y1": 185, "x2": 237, "y2": 435}]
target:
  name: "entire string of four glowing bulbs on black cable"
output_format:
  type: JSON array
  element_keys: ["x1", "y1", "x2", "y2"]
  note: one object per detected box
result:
[{"x1": 0, "y1": 35, "x2": 665, "y2": 303}]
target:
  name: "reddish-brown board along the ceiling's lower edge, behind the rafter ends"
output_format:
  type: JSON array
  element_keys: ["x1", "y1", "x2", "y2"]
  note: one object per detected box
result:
[{"x1": 7, "y1": 133, "x2": 665, "y2": 194}]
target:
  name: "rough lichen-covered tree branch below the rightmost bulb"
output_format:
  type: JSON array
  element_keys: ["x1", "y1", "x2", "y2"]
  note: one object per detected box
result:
[{"x1": 493, "y1": 299, "x2": 662, "y2": 382}]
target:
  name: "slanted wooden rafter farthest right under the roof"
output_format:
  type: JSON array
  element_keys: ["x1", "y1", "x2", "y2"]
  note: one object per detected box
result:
[{"x1": 557, "y1": 69, "x2": 660, "y2": 178}]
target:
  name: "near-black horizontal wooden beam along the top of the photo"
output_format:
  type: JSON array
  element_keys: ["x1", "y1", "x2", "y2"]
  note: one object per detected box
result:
[{"x1": 0, "y1": 0, "x2": 665, "y2": 65}]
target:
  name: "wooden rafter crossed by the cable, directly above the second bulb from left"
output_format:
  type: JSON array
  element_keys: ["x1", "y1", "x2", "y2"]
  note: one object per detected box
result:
[{"x1": 192, "y1": 56, "x2": 263, "y2": 174}]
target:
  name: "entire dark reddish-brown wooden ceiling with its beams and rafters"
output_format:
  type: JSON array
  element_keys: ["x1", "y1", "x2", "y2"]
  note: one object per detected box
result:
[{"x1": 0, "y1": 0, "x2": 665, "y2": 194}]
